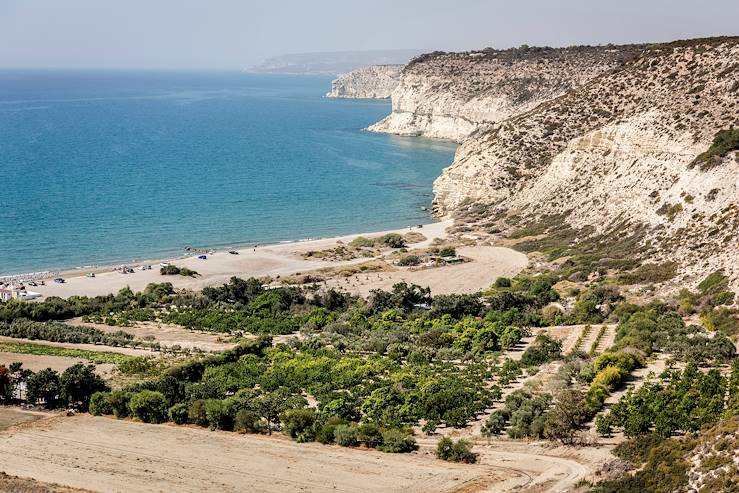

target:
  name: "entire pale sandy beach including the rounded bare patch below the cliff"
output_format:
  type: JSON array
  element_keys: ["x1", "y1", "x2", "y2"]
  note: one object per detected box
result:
[{"x1": 23, "y1": 220, "x2": 528, "y2": 298}]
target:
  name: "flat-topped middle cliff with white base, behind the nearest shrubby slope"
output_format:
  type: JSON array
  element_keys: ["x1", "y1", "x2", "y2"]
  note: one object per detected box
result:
[{"x1": 368, "y1": 46, "x2": 641, "y2": 142}]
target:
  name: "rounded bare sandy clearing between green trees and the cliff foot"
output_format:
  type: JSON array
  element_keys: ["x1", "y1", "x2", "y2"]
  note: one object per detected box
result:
[{"x1": 327, "y1": 246, "x2": 528, "y2": 296}]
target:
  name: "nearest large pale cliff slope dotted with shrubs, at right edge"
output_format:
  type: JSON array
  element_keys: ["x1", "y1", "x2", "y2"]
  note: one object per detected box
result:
[{"x1": 434, "y1": 38, "x2": 739, "y2": 287}]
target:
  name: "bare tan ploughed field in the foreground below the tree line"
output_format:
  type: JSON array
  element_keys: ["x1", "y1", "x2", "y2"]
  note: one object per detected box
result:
[{"x1": 0, "y1": 415, "x2": 500, "y2": 493}]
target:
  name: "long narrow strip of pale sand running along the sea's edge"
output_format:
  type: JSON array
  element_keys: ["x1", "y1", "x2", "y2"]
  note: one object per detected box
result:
[{"x1": 31, "y1": 220, "x2": 452, "y2": 298}]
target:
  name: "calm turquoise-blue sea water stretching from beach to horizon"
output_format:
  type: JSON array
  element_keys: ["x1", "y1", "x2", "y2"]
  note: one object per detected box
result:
[{"x1": 0, "y1": 71, "x2": 455, "y2": 274}]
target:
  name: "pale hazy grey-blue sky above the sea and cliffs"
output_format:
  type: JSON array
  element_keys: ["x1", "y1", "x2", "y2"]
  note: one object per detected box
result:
[{"x1": 0, "y1": 0, "x2": 739, "y2": 69}]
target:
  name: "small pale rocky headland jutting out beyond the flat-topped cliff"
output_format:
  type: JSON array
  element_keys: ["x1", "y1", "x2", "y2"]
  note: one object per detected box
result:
[{"x1": 326, "y1": 65, "x2": 403, "y2": 99}]
